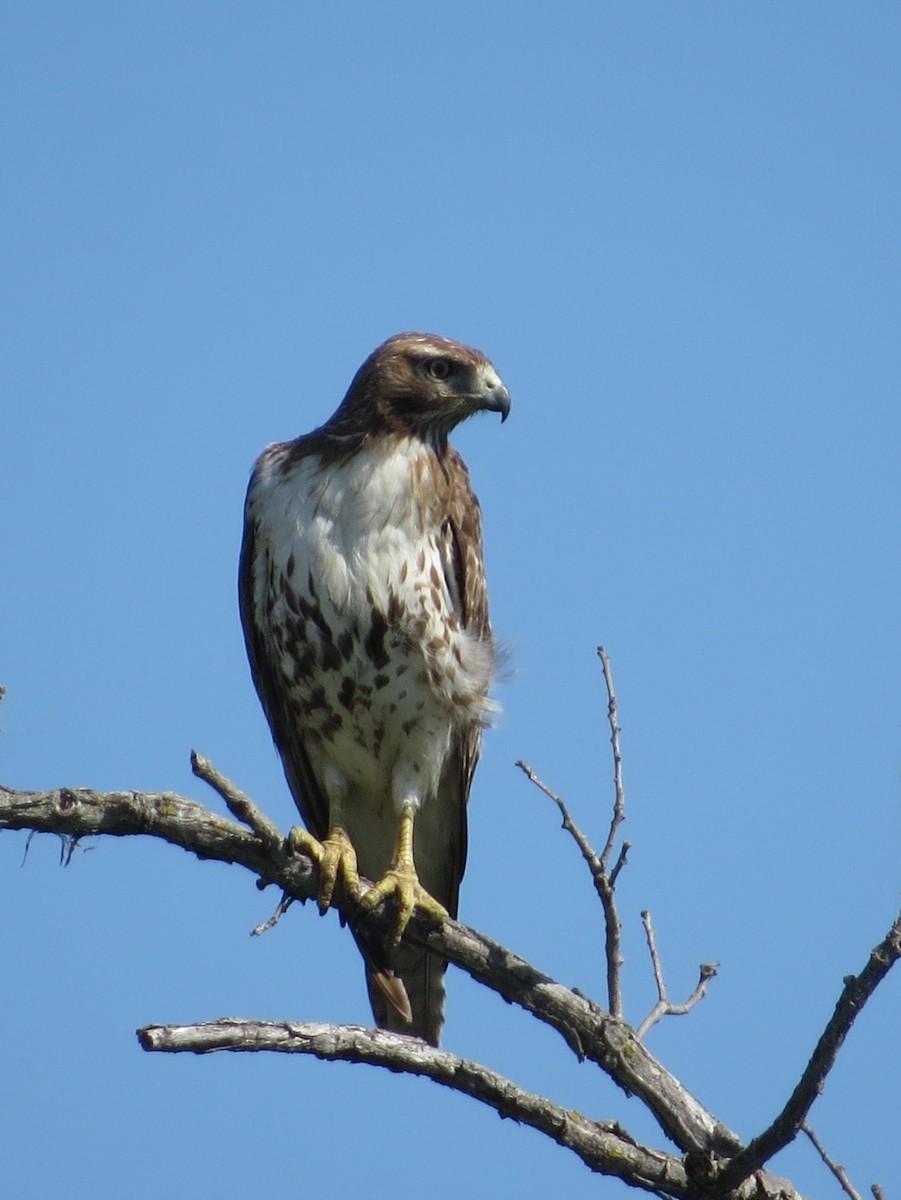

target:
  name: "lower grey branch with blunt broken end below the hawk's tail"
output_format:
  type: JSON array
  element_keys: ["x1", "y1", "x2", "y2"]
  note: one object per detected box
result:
[{"x1": 138, "y1": 1019, "x2": 689, "y2": 1196}]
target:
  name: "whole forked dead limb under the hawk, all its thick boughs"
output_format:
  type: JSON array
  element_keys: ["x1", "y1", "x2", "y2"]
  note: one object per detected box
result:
[{"x1": 0, "y1": 758, "x2": 901, "y2": 1200}]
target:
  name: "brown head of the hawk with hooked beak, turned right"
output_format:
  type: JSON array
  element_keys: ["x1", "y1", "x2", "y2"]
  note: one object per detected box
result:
[{"x1": 332, "y1": 334, "x2": 510, "y2": 443}]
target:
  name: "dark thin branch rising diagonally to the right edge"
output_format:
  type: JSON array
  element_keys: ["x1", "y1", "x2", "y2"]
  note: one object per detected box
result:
[{"x1": 717, "y1": 913, "x2": 901, "y2": 1192}]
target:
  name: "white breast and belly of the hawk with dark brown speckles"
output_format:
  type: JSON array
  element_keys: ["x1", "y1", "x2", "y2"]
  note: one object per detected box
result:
[{"x1": 248, "y1": 442, "x2": 493, "y2": 805}]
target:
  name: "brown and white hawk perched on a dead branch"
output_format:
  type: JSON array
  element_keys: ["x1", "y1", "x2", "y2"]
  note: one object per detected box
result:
[{"x1": 240, "y1": 334, "x2": 510, "y2": 1045}]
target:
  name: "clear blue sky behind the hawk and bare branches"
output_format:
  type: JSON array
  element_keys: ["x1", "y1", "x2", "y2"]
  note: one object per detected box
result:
[{"x1": 0, "y1": 0, "x2": 901, "y2": 1200}]
